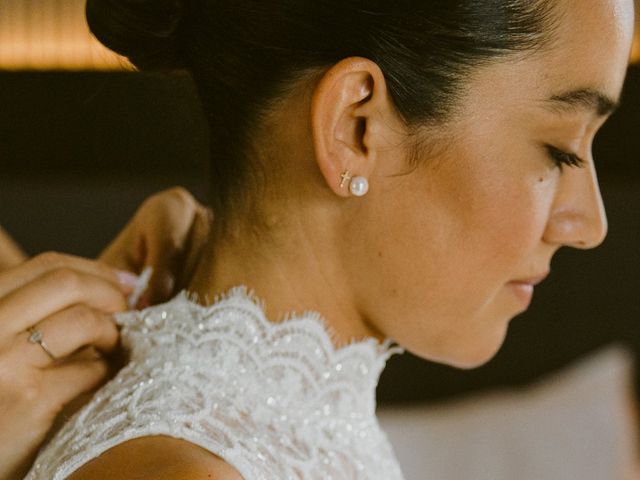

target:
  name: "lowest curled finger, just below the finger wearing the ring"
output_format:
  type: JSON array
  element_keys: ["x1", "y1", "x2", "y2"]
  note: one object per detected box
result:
[{"x1": 42, "y1": 359, "x2": 109, "y2": 414}]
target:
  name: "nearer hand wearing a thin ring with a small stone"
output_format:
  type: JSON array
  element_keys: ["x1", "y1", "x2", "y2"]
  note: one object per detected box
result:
[{"x1": 0, "y1": 253, "x2": 135, "y2": 480}]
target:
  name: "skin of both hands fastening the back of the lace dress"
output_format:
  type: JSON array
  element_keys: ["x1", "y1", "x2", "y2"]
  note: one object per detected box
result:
[{"x1": 0, "y1": 189, "x2": 210, "y2": 480}]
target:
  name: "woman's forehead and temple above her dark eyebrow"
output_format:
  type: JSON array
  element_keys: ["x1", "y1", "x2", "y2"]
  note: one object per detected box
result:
[{"x1": 456, "y1": 0, "x2": 634, "y2": 120}]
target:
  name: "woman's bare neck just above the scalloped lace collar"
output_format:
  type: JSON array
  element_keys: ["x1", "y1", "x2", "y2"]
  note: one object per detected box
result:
[{"x1": 189, "y1": 216, "x2": 383, "y2": 347}]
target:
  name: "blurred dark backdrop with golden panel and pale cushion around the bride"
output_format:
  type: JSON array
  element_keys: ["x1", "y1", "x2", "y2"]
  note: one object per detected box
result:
[{"x1": 0, "y1": 0, "x2": 640, "y2": 480}]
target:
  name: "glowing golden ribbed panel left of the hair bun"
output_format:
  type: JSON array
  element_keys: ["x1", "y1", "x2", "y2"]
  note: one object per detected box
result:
[{"x1": 0, "y1": 0, "x2": 129, "y2": 70}]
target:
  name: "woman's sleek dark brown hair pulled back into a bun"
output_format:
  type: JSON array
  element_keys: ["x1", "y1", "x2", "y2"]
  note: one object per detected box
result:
[{"x1": 87, "y1": 0, "x2": 553, "y2": 235}]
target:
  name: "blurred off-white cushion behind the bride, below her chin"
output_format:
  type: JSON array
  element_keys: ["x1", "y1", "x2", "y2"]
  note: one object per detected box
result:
[{"x1": 379, "y1": 347, "x2": 640, "y2": 480}]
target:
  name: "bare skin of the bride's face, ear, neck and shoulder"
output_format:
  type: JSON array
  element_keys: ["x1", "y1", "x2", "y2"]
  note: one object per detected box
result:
[{"x1": 70, "y1": 0, "x2": 634, "y2": 480}]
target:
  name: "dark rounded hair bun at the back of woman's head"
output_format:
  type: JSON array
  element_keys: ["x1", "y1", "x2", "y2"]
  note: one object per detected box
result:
[{"x1": 86, "y1": 0, "x2": 187, "y2": 70}]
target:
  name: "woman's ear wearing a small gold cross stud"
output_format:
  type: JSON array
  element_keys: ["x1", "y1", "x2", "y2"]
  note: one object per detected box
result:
[{"x1": 311, "y1": 57, "x2": 395, "y2": 197}]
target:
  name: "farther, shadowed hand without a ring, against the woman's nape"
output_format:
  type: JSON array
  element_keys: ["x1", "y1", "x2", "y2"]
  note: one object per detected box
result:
[{"x1": 99, "y1": 188, "x2": 212, "y2": 308}]
